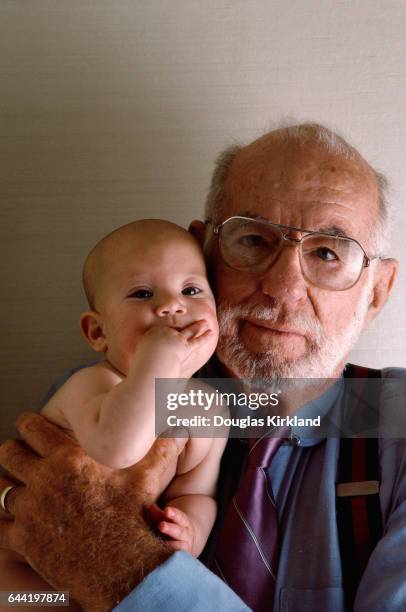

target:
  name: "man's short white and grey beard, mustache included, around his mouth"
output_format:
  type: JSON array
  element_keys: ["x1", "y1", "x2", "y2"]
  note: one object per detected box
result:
[{"x1": 217, "y1": 275, "x2": 373, "y2": 384}]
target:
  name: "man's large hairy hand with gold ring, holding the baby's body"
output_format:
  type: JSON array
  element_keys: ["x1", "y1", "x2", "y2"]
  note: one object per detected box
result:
[{"x1": 0, "y1": 413, "x2": 186, "y2": 611}]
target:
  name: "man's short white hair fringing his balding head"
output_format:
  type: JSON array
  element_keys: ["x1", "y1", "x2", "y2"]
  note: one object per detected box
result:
[{"x1": 205, "y1": 123, "x2": 390, "y2": 255}]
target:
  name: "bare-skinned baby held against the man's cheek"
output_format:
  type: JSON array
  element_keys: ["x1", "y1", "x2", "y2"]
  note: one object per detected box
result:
[{"x1": 1, "y1": 220, "x2": 226, "y2": 590}]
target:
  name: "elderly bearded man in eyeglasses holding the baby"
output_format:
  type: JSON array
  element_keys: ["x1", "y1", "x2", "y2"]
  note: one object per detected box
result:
[{"x1": 0, "y1": 124, "x2": 406, "y2": 612}]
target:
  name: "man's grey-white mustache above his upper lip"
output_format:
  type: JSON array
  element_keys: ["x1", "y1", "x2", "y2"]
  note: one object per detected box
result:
[{"x1": 217, "y1": 303, "x2": 323, "y2": 345}]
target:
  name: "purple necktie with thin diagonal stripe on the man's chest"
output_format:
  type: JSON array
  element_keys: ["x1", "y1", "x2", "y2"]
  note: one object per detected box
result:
[{"x1": 214, "y1": 436, "x2": 286, "y2": 611}]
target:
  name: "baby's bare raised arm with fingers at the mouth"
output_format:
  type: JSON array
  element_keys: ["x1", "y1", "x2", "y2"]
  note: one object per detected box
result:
[{"x1": 43, "y1": 321, "x2": 213, "y2": 468}]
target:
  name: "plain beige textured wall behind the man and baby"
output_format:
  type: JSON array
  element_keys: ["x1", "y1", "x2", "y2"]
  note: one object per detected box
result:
[{"x1": 0, "y1": 0, "x2": 406, "y2": 437}]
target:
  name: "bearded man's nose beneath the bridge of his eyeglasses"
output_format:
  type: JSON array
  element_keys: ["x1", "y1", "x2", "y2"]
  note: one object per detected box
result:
[{"x1": 260, "y1": 244, "x2": 308, "y2": 306}]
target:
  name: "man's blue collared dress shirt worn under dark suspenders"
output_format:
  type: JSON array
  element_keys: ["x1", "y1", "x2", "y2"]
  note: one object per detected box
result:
[{"x1": 115, "y1": 368, "x2": 406, "y2": 612}]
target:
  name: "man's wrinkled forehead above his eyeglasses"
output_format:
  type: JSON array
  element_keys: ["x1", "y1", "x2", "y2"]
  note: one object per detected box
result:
[{"x1": 221, "y1": 143, "x2": 378, "y2": 241}]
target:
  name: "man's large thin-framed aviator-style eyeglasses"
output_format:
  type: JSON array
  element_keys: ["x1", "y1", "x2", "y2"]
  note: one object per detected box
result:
[{"x1": 209, "y1": 217, "x2": 381, "y2": 291}]
